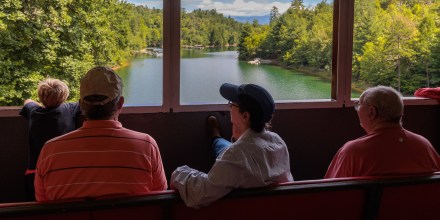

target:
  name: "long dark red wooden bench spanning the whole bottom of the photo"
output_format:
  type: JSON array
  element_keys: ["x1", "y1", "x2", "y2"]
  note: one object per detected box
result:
[{"x1": 0, "y1": 173, "x2": 440, "y2": 220}]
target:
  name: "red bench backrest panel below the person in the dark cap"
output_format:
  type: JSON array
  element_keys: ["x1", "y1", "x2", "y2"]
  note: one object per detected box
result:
[{"x1": 173, "y1": 189, "x2": 365, "y2": 220}]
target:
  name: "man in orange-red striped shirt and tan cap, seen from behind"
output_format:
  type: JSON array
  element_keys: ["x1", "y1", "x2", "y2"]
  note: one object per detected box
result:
[{"x1": 35, "y1": 67, "x2": 167, "y2": 201}]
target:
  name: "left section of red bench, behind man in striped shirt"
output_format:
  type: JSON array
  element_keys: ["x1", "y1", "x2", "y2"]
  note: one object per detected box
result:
[{"x1": 0, "y1": 190, "x2": 173, "y2": 220}]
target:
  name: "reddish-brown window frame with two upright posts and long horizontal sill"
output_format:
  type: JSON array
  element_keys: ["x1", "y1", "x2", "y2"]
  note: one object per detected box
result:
[{"x1": 0, "y1": 0, "x2": 439, "y2": 117}]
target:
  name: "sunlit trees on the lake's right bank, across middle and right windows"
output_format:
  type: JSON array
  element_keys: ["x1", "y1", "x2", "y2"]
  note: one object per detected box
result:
[{"x1": 238, "y1": 0, "x2": 440, "y2": 95}]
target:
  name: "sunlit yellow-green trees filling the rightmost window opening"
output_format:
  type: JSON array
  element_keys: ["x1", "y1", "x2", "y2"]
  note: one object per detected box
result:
[{"x1": 353, "y1": 1, "x2": 439, "y2": 94}]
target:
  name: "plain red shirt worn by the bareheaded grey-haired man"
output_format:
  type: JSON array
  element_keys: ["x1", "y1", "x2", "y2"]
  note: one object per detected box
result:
[{"x1": 325, "y1": 127, "x2": 440, "y2": 178}]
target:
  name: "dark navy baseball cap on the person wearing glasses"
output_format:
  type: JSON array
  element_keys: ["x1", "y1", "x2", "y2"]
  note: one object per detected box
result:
[{"x1": 220, "y1": 83, "x2": 275, "y2": 123}]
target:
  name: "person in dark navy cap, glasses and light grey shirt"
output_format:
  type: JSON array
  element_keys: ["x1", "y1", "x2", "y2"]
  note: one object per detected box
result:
[{"x1": 170, "y1": 83, "x2": 293, "y2": 208}]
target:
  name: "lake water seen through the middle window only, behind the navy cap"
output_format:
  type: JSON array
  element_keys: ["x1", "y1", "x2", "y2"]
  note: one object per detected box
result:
[{"x1": 180, "y1": 51, "x2": 331, "y2": 104}]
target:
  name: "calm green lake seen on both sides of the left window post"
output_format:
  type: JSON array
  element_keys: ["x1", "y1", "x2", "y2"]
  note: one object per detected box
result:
[{"x1": 117, "y1": 49, "x2": 331, "y2": 106}]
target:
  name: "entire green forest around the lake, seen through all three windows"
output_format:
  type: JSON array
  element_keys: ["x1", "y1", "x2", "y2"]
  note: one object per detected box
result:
[{"x1": 0, "y1": 0, "x2": 440, "y2": 106}]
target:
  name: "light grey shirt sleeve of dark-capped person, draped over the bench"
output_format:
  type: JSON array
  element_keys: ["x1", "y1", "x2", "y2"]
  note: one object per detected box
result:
[{"x1": 170, "y1": 150, "x2": 243, "y2": 208}]
